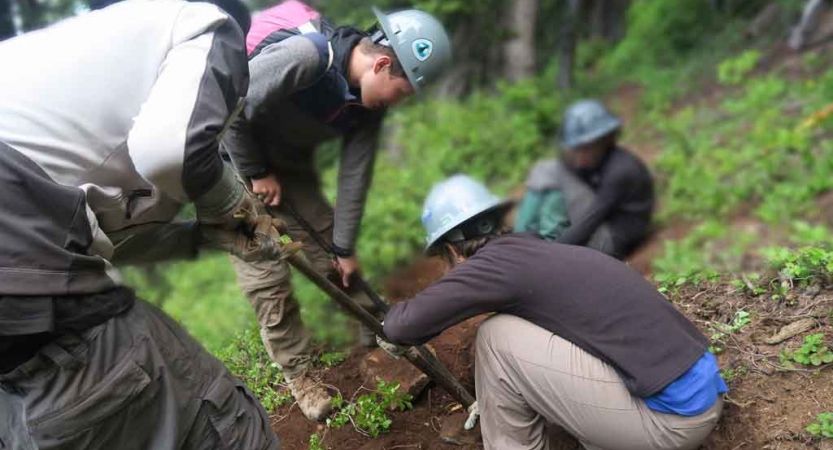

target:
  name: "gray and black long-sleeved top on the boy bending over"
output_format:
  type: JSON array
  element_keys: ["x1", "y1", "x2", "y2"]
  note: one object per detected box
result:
[{"x1": 223, "y1": 34, "x2": 383, "y2": 250}]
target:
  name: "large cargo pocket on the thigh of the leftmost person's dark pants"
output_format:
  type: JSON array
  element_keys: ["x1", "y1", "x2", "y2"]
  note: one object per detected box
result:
[{"x1": 27, "y1": 358, "x2": 158, "y2": 449}]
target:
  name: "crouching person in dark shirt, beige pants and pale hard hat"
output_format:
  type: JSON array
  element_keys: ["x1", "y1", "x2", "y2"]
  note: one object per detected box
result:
[{"x1": 380, "y1": 175, "x2": 727, "y2": 450}]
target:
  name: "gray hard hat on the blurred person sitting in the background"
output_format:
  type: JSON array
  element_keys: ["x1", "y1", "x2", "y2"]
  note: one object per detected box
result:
[{"x1": 561, "y1": 100, "x2": 622, "y2": 150}]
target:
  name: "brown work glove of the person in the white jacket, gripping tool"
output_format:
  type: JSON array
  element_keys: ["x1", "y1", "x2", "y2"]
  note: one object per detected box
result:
[{"x1": 194, "y1": 165, "x2": 268, "y2": 230}]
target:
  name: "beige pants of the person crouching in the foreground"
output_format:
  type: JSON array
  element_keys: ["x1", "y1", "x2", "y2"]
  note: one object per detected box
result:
[{"x1": 475, "y1": 314, "x2": 723, "y2": 450}]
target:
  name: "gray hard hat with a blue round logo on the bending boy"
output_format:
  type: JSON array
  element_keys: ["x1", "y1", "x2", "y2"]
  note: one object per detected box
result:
[{"x1": 371, "y1": 8, "x2": 451, "y2": 91}]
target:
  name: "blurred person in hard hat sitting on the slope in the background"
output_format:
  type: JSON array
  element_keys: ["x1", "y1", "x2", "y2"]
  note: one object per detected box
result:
[{"x1": 515, "y1": 100, "x2": 654, "y2": 258}]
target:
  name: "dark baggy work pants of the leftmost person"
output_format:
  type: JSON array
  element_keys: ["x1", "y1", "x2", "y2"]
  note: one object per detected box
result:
[{"x1": 0, "y1": 300, "x2": 280, "y2": 450}]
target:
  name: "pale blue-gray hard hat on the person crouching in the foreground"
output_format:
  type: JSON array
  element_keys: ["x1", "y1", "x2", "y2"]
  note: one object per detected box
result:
[{"x1": 422, "y1": 175, "x2": 511, "y2": 250}]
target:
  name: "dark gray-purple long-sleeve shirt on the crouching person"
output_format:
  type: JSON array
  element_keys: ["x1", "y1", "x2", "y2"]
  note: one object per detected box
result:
[{"x1": 384, "y1": 234, "x2": 708, "y2": 397}]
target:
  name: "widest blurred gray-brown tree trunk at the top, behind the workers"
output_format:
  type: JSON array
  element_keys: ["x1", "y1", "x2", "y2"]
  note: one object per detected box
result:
[{"x1": 504, "y1": 0, "x2": 538, "y2": 81}]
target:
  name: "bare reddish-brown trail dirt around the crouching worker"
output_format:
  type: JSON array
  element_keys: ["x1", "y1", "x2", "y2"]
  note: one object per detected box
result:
[{"x1": 273, "y1": 255, "x2": 833, "y2": 450}]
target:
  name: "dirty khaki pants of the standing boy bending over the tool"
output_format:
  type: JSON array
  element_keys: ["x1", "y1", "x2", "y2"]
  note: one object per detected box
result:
[{"x1": 231, "y1": 172, "x2": 372, "y2": 377}]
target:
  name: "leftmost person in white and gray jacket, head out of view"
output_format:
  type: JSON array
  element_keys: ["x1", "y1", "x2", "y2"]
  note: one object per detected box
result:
[{"x1": 0, "y1": 0, "x2": 279, "y2": 450}]
